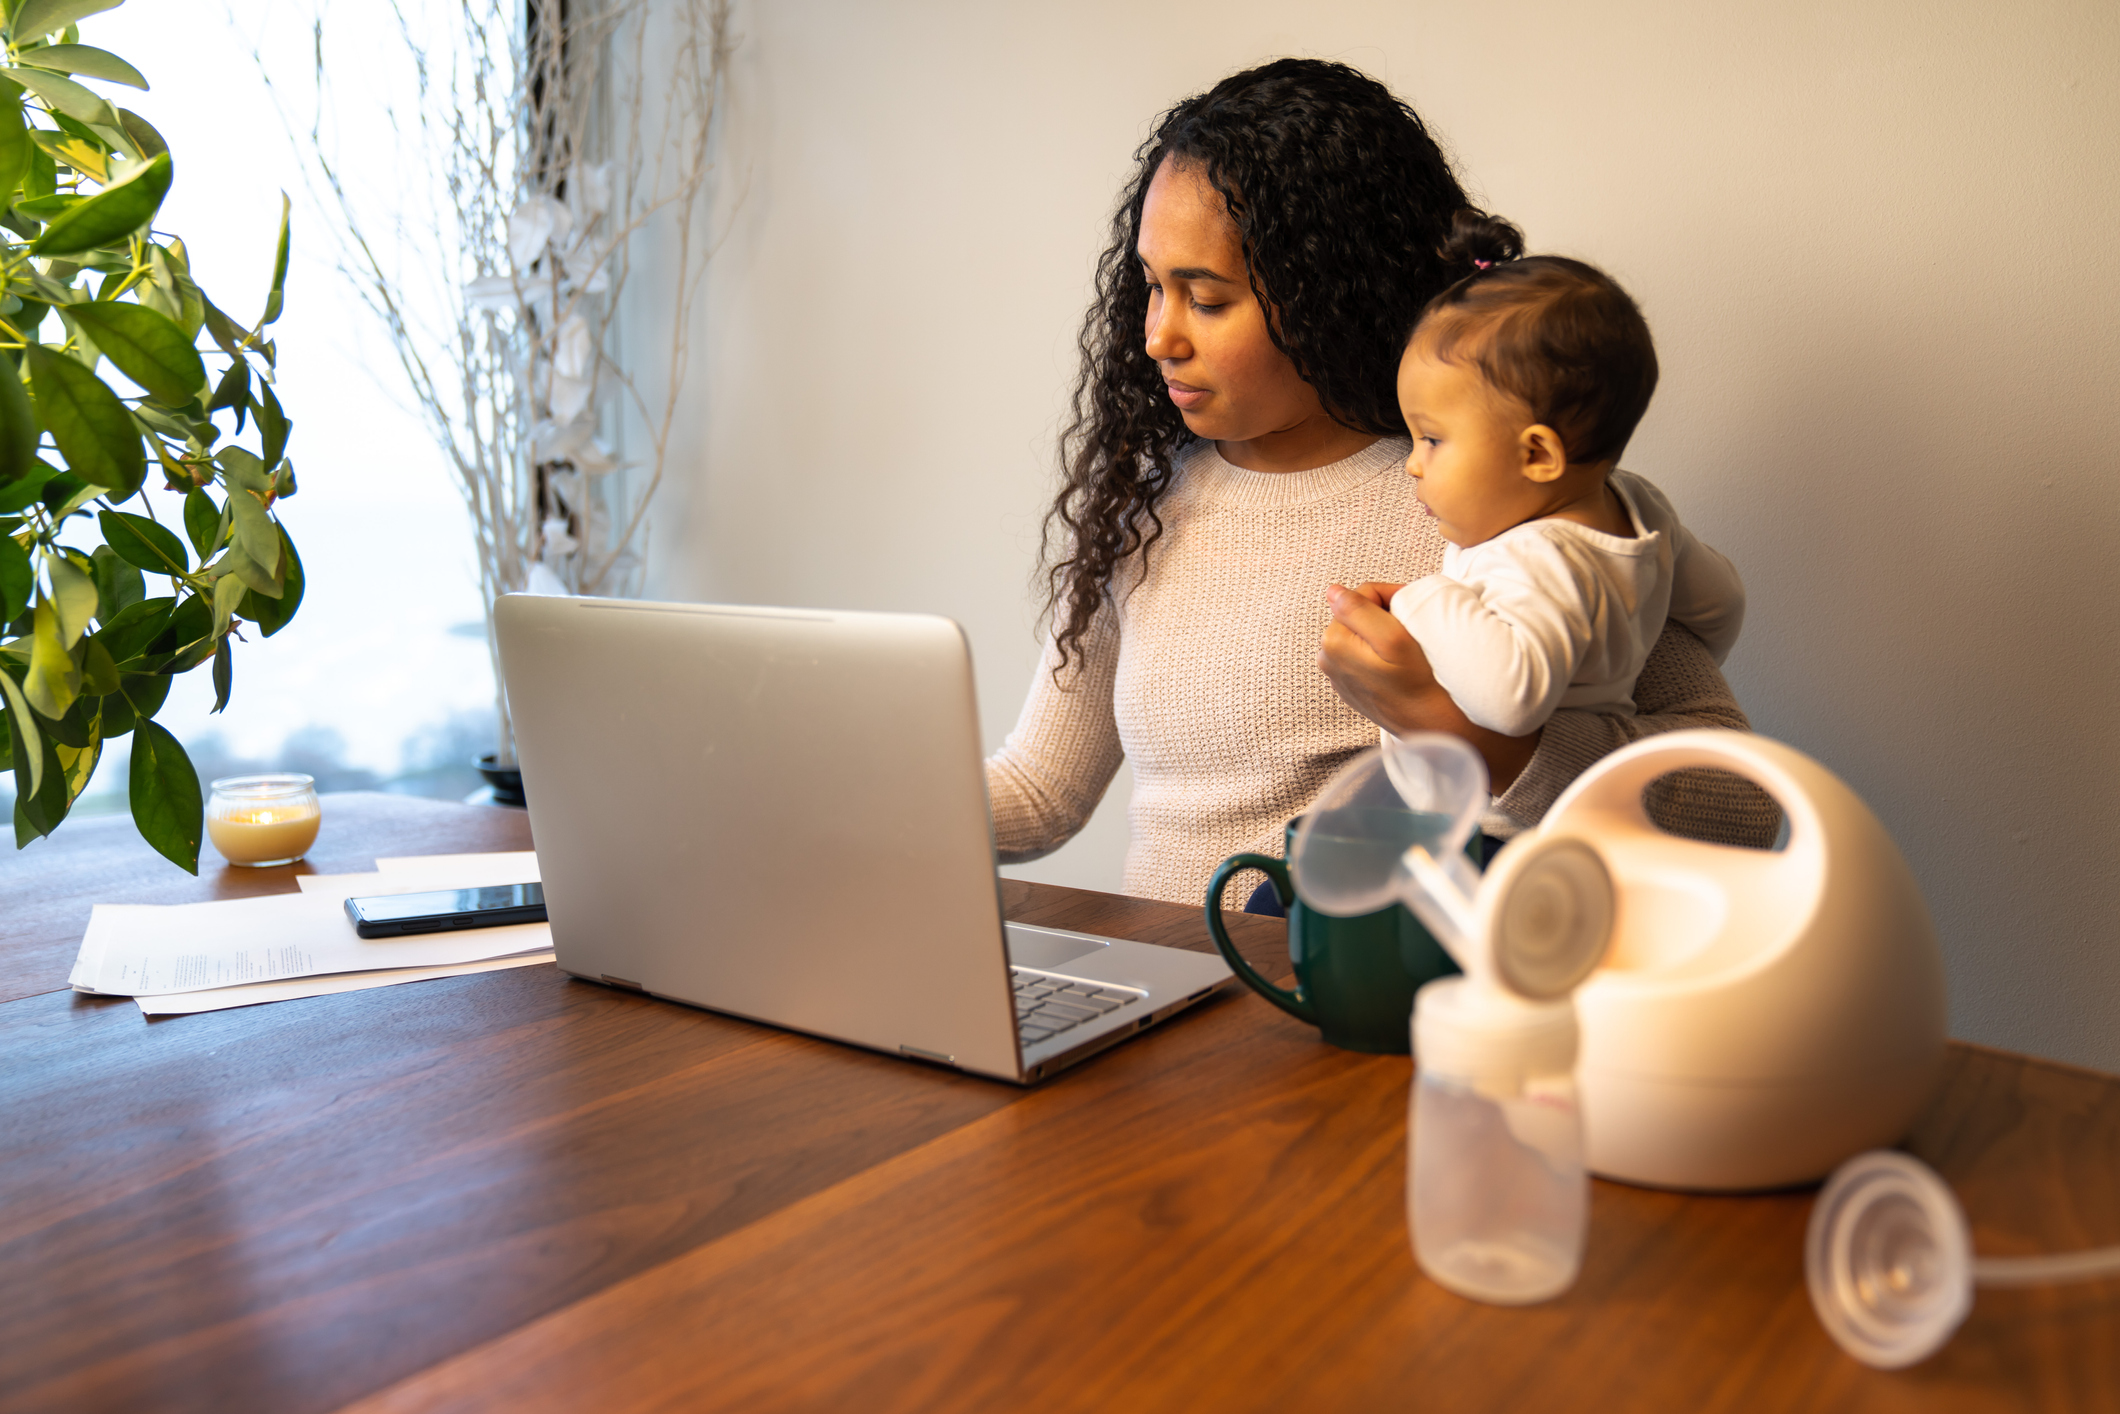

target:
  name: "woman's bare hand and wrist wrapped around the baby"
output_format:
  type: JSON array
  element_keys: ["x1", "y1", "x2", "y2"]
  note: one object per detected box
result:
[{"x1": 1319, "y1": 581, "x2": 1543, "y2": 795}]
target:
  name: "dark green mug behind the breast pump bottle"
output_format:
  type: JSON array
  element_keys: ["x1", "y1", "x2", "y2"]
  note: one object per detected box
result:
[{"x1": 1206, "y1": 818, "x2": 1482, "y2": 1056}]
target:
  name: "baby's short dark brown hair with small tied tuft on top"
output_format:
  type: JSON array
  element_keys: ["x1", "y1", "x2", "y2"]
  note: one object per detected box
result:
[{"x1": 1410, "y1": 208, "x2": 1656, "y2": 464}]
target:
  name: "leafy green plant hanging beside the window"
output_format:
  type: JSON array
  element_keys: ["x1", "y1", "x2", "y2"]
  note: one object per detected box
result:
[{"x1": 0, "y1": 0, "x2": 303, "y2": 873}]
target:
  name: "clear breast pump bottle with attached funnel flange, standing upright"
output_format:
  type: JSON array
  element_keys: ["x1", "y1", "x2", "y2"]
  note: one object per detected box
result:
[{"x1": 1289, "y1": 733, "x2": 1613, "y2": 1306}]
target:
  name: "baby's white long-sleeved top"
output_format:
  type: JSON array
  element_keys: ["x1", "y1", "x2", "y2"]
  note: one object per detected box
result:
[{"x1": 1391, "y1": 471, "x2": 1745, "y2": 736}]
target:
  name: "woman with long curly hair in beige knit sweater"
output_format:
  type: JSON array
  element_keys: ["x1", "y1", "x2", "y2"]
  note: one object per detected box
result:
[{"x1": 986, "y1": 59, "x2": 1774, "y2": 903}]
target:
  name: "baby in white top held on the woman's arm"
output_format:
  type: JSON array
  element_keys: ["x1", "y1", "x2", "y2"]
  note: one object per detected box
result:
[{"x1": 1391, "y1": 212, "x2": 1745, "y2": 736}]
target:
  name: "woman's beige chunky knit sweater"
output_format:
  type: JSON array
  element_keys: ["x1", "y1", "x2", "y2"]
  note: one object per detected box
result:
[{"x1": 986, "y1": 439, "x2": 1779, "y2": 903}]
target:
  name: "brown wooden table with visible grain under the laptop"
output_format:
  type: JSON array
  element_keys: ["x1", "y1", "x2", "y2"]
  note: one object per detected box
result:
[{"x1": 0, "y1": 795, "x2": 2120, "y2": 1414}]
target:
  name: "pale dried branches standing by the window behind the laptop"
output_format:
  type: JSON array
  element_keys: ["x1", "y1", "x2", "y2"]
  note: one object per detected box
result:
[{"x1": 267, "y1": 0, "x2": 731, "y2": 765}]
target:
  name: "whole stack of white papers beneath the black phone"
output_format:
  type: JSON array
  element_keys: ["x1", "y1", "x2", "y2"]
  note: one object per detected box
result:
[{"x1": 70, "y1": 850, "x2": 551, "y2": 1015}]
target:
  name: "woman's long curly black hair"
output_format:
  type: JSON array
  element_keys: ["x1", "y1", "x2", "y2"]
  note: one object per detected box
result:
[{"x1": 1041, "y1": 59, "x2": 1467, "y2": 672}]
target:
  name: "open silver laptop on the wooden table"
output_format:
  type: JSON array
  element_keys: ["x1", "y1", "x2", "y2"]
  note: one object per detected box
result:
[{"x1": 494, "y1": 594, "x2": 1232, "y2": 1083}]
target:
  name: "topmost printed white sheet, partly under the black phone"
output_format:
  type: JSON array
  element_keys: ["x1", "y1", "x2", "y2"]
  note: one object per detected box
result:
[{"x1": 70, "y1": 888, "x2": 551, "y2": 996}]
